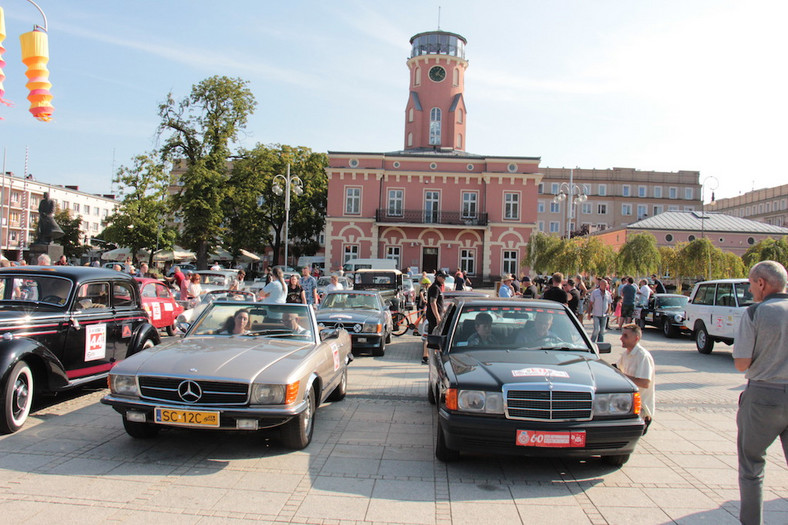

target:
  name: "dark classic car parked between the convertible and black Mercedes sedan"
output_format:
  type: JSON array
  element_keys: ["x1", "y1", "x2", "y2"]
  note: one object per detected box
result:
[{"x1": 316, "y1": 290, "x2": 393, "y2": 356}]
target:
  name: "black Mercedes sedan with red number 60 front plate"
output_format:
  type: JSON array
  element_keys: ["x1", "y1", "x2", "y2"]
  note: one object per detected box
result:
[{"x1": 427, "y1": 299, "x2": 644, "y2": 466}]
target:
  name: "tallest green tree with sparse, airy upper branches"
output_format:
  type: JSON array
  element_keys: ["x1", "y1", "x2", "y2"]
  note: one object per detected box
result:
[{"x1": 159, "y1": 76, "x2": 257, "y2": 268}]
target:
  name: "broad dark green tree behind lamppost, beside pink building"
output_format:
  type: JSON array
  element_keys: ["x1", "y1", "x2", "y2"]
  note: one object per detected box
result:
[{"x1": 224, "y1": 144, "x2": 328, "y2": 264}]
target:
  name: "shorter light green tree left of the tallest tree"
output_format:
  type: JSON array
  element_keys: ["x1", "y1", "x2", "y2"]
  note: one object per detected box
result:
[{"x1": 102, "y1": 153, "x2": 176, "y2": 263}]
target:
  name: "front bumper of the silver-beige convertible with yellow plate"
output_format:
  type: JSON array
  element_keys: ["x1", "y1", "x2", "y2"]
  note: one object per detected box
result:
[{"x1": 101, "y1": 394, "x2": 306, "y2": 430}]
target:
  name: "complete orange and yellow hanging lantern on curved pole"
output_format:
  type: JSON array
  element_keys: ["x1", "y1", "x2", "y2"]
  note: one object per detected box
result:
[{"x1": 19, "y1": 27, "x2": 55, "y2": 122}]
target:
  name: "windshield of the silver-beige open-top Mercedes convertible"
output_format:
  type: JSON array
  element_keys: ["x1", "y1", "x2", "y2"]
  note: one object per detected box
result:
[{"x1": 189, "y1": 303, "x2": 314, "y2": 341}]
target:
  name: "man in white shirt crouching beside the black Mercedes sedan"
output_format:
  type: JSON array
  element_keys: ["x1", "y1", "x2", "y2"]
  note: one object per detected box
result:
[{"x1": 616, "y1": 323, "x2": 656, "y2": 435}]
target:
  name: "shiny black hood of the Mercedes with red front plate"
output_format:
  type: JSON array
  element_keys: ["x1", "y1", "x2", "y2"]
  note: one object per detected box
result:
[{"x1": 447, "y1": 350, "x2": 634, "y2": 392}]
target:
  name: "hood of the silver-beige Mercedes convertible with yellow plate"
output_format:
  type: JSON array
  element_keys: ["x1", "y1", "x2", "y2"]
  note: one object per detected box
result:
[{"x1": 112, "y1": 336, "x2": 314, "y2": 381}]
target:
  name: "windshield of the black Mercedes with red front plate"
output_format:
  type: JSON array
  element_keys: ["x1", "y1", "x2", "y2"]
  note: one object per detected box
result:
[{"x1": 452, "y1": 305, "x2": 590, "y2": 352}]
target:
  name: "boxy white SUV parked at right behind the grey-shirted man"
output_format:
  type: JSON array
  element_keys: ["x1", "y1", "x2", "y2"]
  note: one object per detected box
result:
[{"x1": 684, "y1": 279, "x2": 752, "y2": 354}]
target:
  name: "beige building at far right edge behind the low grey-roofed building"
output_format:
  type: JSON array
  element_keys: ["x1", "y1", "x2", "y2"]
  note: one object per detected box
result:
[{"x1": 706, "y1": 184, "x2": 788, "y2": 226}]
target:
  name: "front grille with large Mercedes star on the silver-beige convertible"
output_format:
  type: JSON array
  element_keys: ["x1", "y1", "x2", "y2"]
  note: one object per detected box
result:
[{"x1": 139, "y1": 376, "x2": 249, "y2": 405}]
